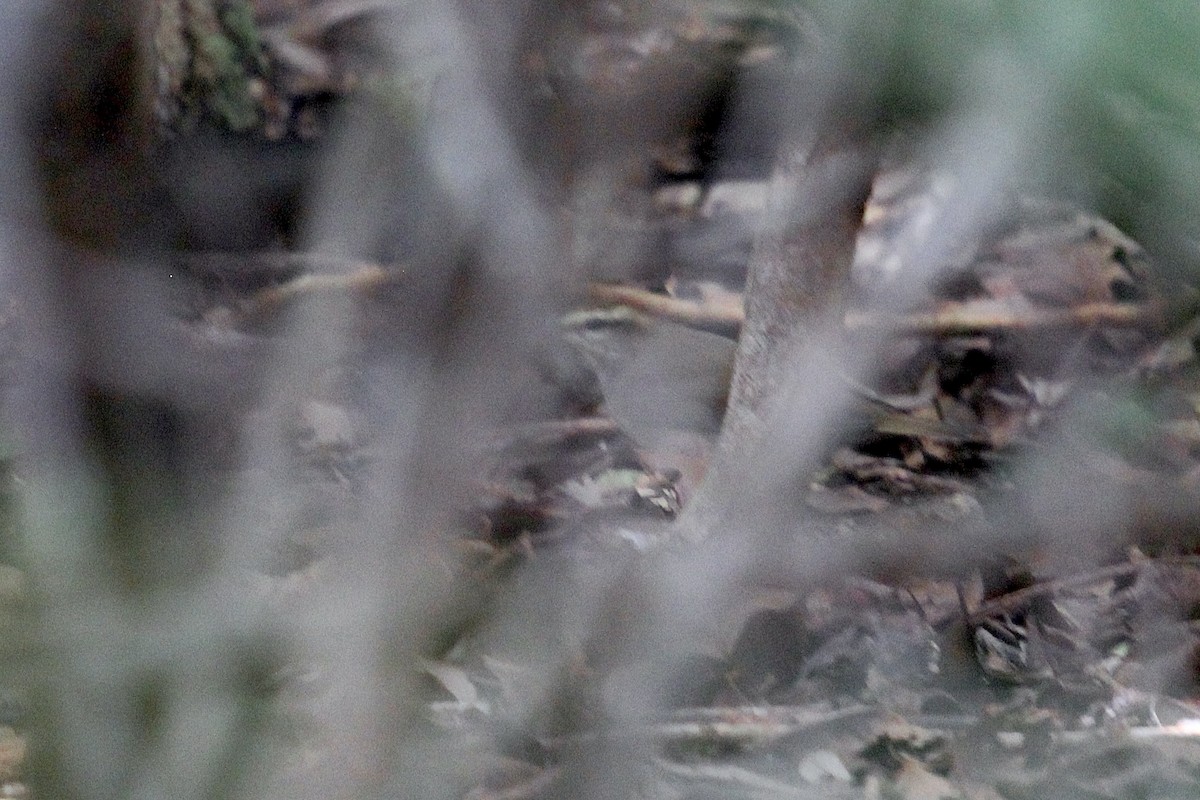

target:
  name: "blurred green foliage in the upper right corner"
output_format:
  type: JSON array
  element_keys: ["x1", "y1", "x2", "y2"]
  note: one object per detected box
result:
[{"x1": 805, "y1": 0, "x2": 1200, "y2": 276}]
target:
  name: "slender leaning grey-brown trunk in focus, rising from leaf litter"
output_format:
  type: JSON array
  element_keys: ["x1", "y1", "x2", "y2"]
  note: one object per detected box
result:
[{"x1": 685, "y1": 120, "x2": 876, "y2": 544}]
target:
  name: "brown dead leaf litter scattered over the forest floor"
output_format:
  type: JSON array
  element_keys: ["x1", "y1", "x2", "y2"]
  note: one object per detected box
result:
[{"x1": 11, "y1": 2, "x2": 1200, "y2": 799}]
